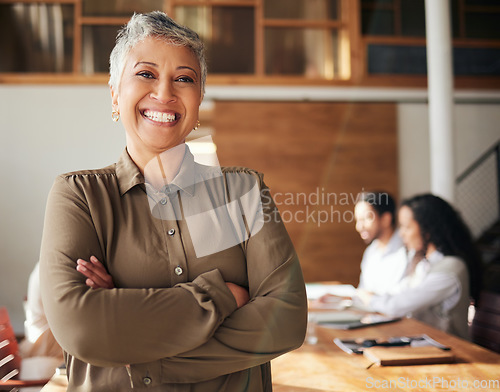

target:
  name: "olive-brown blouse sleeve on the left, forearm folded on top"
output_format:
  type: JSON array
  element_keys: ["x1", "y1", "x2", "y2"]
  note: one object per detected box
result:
[{"x1": 40, "y1": 176, "x2": 236, "y2": 366}]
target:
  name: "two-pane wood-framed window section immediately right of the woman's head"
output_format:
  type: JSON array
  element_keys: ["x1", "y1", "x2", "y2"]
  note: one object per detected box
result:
[{"x1": 173, "y1": 0, "x2": 350, "y2": 80}]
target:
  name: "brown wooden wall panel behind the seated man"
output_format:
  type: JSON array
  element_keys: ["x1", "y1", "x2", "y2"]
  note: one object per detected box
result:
[{"x1": 212, "y1": 101, "x2": 398, "y2": 284}]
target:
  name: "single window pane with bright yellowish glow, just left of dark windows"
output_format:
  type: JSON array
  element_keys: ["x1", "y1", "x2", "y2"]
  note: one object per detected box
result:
[{"x1": 263, "y1": 0, "x2": 350, "y2": 80}]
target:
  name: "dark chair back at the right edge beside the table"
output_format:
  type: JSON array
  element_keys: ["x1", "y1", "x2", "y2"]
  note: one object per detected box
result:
[{"x1": 471, "y1": 291, "x2": 500, "y2": 353}]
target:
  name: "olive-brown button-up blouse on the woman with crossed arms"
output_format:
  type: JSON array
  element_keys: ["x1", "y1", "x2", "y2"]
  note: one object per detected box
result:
[{"x1": 40, "y1": 148, "x2": 307, "y2": 392}]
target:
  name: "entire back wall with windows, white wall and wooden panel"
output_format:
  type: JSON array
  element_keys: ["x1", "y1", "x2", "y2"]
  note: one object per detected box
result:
[{"x1": 0, "y1": 0, "x2": 500, "y2": 333}]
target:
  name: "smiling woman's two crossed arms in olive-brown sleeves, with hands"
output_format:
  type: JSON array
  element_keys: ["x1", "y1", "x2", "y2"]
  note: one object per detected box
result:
[{"x1": 41, "y1": 173, "x2": 307, "y2": 383}]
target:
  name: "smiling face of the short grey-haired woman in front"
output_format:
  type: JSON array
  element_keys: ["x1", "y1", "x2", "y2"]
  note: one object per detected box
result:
[{"x1": 111, "y1": 37, "x2": 203, "y2": 169}]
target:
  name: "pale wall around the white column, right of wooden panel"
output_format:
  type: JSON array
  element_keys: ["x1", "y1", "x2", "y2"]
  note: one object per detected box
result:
[{"x1": 398, "y1": 103, "x2": 500, "y2": 237}]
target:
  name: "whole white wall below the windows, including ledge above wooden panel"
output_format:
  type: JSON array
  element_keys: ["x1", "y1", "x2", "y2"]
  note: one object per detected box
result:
[{"x1": 0, "y1": 85, "x2": 500, "y2": 333}]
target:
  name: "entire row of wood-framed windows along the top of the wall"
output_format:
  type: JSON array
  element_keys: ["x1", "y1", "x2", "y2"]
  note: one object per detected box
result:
[{"x1": 0, "y1": 0, "x2": 500, "y2": 88}]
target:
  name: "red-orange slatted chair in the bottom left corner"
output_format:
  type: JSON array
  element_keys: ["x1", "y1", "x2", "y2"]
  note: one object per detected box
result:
[{"x1": 0, "y1": 307, "x2": 49, "y2": 391}]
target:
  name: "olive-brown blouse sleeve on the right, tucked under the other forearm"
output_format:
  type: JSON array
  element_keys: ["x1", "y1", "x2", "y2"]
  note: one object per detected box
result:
[{"x1": 131, "y1": 172, "x2": 307, "y2": 383}]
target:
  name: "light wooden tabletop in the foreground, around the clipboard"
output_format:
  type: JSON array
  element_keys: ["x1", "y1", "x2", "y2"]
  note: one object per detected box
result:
[{"x1": 271, "y1": 319, "x2": 500, "y2": 392}]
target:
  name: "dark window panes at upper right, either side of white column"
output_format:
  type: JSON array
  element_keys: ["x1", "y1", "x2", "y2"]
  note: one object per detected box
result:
[{"x1": 361, "y1": 0, "x2": 500, "y2": 77}]
